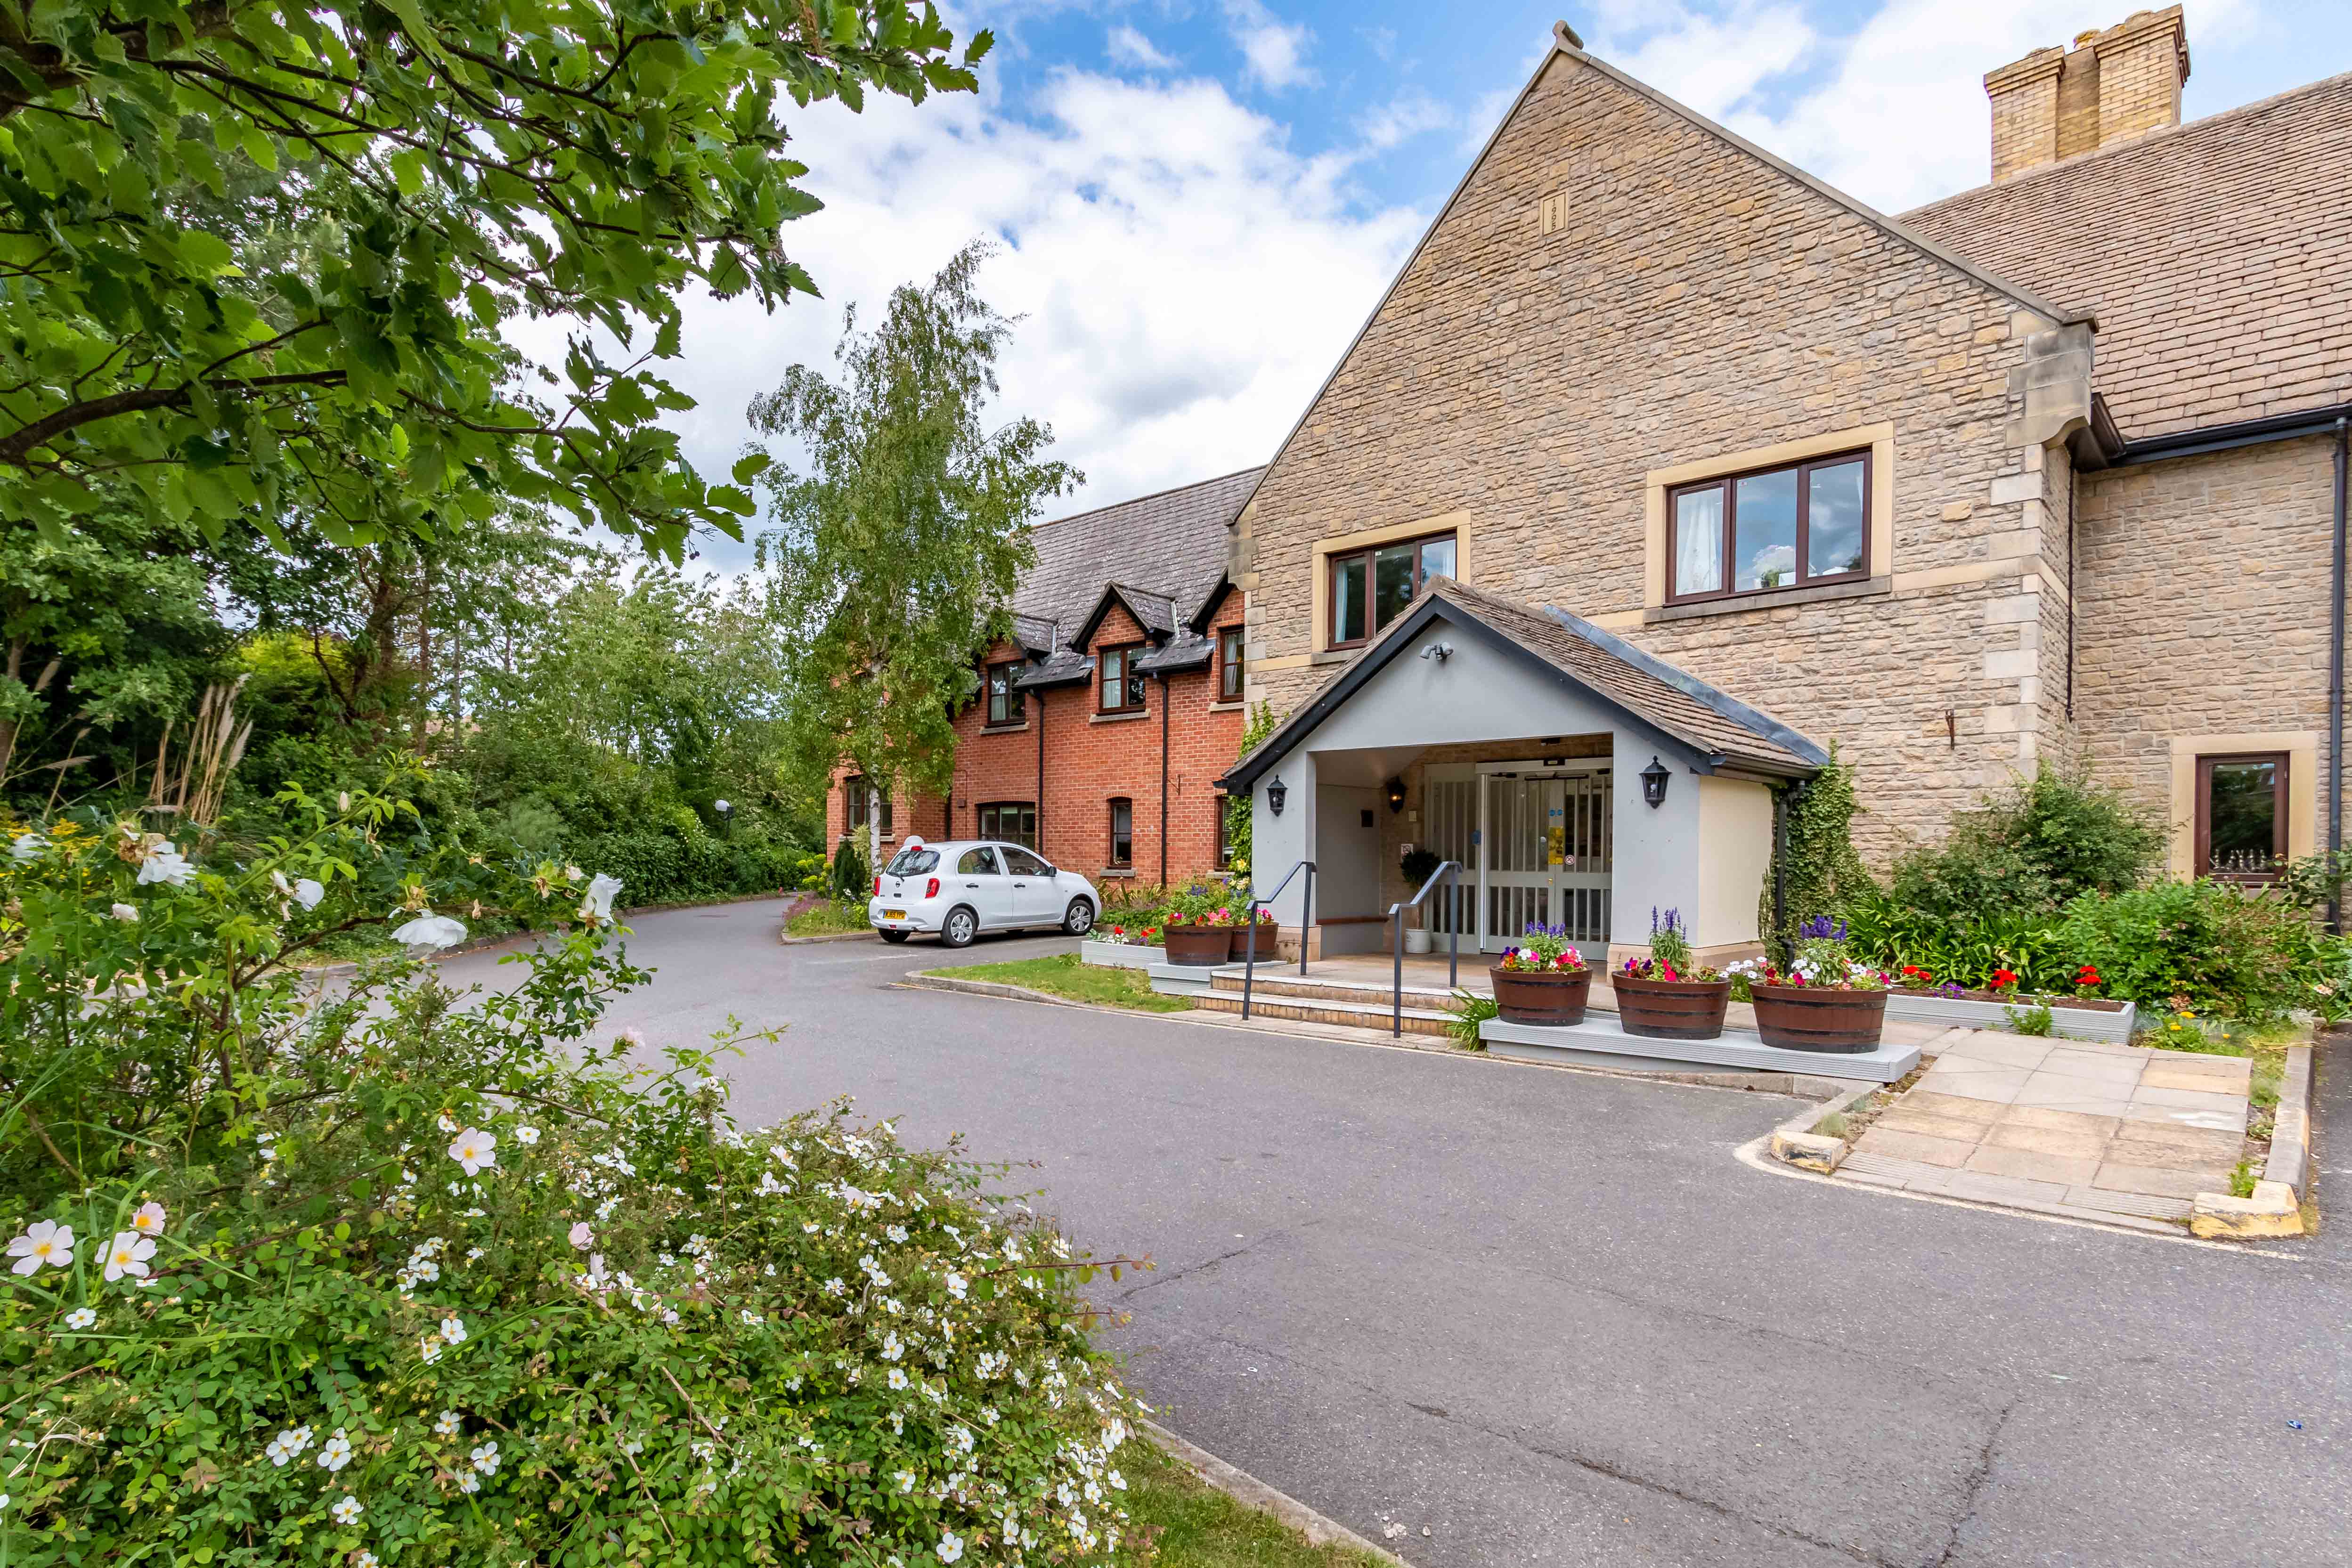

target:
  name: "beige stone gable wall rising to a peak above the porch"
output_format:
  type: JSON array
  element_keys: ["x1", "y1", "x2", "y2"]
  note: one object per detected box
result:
[{"x1": 1242, "y1": 57, "x2": 2063, "y2": 858}]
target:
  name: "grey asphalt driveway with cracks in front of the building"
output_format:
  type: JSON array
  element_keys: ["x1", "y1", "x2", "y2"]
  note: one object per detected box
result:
[{"x1": 437, "y1": 905, "x2": 2352, "y2": 1568}]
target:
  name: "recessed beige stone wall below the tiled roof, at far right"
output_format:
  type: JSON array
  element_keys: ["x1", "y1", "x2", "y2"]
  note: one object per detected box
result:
[{"x1": 2075, "y1": 437, "x2": 2333, "y2": 835}]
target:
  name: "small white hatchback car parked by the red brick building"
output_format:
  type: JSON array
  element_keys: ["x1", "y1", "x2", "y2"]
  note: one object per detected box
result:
[{"x1": 865, "y1": 839, "x2": 1103, "y2": 947}]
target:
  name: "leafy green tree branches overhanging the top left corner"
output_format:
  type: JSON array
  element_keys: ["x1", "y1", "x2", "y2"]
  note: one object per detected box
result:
[{"x1": 0, "y1": 0, "x2": 990, "y2": 555}]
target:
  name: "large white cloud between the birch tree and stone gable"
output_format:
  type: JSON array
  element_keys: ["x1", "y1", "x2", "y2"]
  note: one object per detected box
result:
[{"x1": 607, "y1": 71, "x2": 1425, "y2": 564}]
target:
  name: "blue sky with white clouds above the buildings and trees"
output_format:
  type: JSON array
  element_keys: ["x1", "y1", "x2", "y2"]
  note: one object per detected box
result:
[{"x1": 611, "y1": 0, "x2": 2352, "y2": 571}]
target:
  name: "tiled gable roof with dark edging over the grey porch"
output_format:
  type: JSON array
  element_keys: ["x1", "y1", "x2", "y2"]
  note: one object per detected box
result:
[{"x1": 1216, "y1": 578, "x2": 1830, "y2": 795}]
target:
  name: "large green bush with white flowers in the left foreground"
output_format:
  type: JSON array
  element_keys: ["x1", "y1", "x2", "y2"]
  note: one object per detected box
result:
[{"x1": 0, "y1": 799, "x2": 1141, "y2": 1568}]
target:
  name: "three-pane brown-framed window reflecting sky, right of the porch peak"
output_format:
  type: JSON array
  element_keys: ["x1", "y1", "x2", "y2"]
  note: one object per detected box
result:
[{"x1": 1665, "y1": 451, "x2": 1872, "y2": 604}]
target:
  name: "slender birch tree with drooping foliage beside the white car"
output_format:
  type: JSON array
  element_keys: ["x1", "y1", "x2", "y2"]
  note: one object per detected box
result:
[{"x1": 750, "y1": 242, "x2": 1084, "y2": 861}]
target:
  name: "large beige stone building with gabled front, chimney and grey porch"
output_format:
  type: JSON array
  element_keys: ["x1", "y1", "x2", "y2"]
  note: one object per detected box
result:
[{"x1": 1223, "y1": 7, "x2": 2352, "y2": 968}]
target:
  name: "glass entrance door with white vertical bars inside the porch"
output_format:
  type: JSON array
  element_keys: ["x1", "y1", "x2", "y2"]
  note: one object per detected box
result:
[{"x1": 1480, "y1": 769, "x2": 1611, "y2": 959}]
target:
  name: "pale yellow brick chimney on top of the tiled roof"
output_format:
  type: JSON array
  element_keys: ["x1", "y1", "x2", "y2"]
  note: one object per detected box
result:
[{"x1": 1985, "y1": 5, "x2": 2189, "y2": 181}]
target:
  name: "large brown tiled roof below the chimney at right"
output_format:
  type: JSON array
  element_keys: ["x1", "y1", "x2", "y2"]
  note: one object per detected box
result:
[{"x1": 1903, "y1": 73, "x2": 2352, "y2": 439}]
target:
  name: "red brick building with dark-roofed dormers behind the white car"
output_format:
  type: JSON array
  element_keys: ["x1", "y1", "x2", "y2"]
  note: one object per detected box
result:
[{"x1": 828, "y1": 468, "x2": 1258, "y2": 884}]
